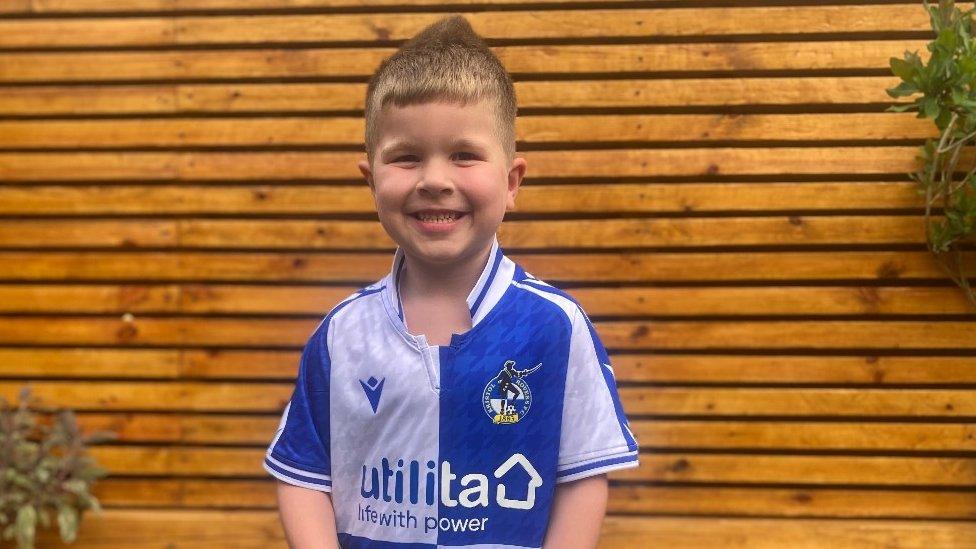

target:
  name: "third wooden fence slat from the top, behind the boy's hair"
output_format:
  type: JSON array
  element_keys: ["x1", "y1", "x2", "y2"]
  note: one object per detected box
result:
[{"x1": 0, "y1": 40, "x2": 926, "y2": 84}]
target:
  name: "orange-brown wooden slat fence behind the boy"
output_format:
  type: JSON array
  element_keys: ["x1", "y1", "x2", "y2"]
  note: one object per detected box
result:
[{"x1": 0, "y1": 0, "x2": 976, "y2": 549}]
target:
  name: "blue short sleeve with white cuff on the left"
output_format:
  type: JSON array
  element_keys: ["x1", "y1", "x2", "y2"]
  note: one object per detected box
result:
[{"x1": 264, "y1": 323, "x2": 332, "y2": 492}]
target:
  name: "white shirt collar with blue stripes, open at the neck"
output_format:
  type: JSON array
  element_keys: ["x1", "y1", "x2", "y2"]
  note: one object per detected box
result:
[{"x1": 384, "y1": 235, "x2": 515, "y2": 327}]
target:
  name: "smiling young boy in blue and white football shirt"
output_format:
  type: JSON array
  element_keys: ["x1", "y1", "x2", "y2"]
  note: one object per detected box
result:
[{"x1": 264, "y1": 16, "x2": 637, "y2": 549}]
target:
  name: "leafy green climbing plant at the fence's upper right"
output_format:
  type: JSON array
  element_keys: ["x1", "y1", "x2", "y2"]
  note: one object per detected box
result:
[{"x1": 887, "y1": 0, "x2": 976, "y2": 306}]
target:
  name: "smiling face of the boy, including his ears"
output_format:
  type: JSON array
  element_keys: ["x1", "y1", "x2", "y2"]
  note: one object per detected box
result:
[{"x1": 359, "y1": 101, "x2": 525, "y2": 266}]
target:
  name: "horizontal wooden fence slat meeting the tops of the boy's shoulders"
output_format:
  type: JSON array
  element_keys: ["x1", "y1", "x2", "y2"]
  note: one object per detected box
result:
[{"x1": 0, "y1": 284, "x2": 972, "y2": 317}]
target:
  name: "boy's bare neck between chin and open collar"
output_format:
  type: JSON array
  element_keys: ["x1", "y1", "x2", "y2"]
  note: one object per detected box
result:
[{"x1": 400, "y1": 246, "x2": 491, "y2": 300}]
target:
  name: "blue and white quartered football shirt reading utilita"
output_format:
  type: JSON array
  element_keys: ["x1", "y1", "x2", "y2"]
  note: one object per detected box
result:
[{"x1": 264, "y1": 239, "x2": 637, "y2": 549}]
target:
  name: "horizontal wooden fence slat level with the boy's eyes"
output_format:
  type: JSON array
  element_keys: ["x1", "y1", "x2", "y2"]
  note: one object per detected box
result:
[{"x1": 0, "y1": 147, "x2": 932, "y2": 182}]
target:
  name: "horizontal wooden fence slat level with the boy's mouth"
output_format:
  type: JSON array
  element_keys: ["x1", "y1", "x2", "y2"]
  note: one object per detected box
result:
[{"x1": 0, "y1": 216, "x2": 925, "y2": 250}]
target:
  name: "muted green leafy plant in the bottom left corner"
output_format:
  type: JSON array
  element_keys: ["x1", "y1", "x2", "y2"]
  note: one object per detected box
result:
[{"x1": 0, "y1": 387, "x2": 116, "y2": 549}]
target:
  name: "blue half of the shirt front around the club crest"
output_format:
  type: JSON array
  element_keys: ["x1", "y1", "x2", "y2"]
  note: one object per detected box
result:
[{"x1": 438, "y1": 288, "x2": 570, "y2": 547}]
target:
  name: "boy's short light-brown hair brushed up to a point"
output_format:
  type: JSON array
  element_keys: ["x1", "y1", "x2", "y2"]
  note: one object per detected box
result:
[{"x1": 365, "y1": 15, "x2": 517, "y2": 163}]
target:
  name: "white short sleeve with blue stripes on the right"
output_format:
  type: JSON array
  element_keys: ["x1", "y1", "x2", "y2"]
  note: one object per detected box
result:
[{"x1": 556, "y1": 308, "x2": 638, "y2": 482}]
